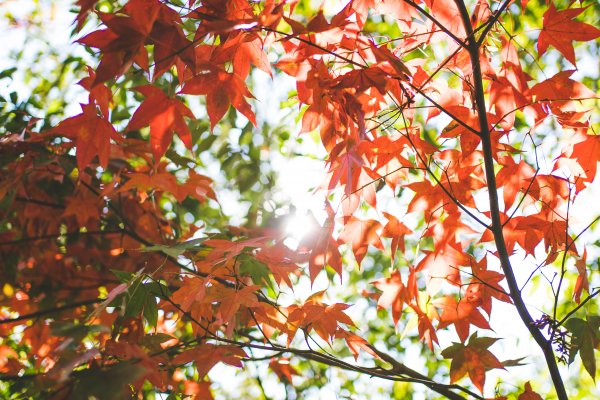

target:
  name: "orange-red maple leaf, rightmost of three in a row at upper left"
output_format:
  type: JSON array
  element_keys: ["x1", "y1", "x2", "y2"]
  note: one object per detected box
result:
[{"x1": 181, "y1": 70, "x2": 256, "y2": 129}]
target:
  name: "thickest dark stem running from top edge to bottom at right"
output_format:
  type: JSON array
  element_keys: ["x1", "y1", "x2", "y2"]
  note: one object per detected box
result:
[{"x1": 455, "y1": 0, "x2": 568, "y2": 400}]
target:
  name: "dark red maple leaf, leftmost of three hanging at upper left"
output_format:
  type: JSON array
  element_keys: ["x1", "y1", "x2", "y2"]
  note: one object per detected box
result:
[{"x1": 50, "y1": 104, "x2": 122, "y2": 172}]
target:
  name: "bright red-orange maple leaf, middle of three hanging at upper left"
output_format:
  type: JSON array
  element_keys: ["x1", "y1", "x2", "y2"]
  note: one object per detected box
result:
[{"x1": 126, "y1": 85, "x2": 194, "y2": 161}]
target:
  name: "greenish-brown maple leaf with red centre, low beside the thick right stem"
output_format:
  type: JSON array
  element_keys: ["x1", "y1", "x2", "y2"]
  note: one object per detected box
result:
[{"x1": 442, "y1": 332, "x2": 504, "y2": 393}]
